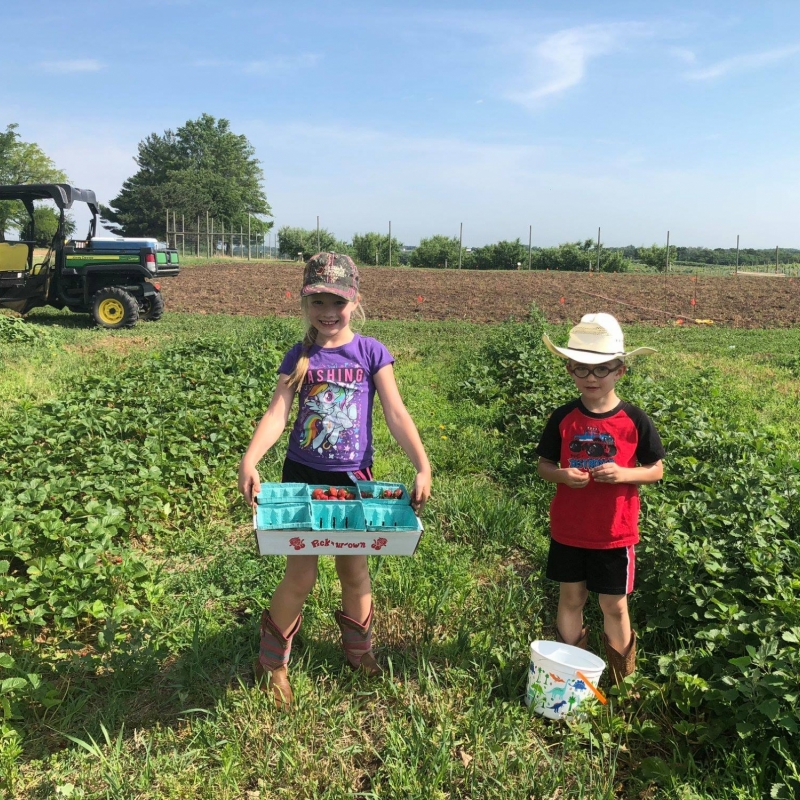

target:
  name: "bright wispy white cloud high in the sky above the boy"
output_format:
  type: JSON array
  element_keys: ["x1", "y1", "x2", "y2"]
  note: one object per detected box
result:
[{"x1": 507, "y1": 22, "x2": 650, "y2": 108}]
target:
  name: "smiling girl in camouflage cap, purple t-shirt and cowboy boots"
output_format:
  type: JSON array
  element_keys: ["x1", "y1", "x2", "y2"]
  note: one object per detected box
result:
[{"x1": 239, "y1": 253, "x2": 431, "y2": 708}]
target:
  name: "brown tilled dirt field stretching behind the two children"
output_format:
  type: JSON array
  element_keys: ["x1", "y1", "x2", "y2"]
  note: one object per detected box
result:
[{"x1": 162, "y1": 261, "x2": 800, "y2": 328}]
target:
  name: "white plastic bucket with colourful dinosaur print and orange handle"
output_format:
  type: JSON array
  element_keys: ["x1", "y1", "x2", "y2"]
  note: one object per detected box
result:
[{"x1": 525, "y1": 640, "x2": 606, "y2": 719}]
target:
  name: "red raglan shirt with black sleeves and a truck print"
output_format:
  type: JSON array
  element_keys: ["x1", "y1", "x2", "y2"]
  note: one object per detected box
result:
[{"x1": 536, "y1": 398, "x2": 665, "y2": 550}]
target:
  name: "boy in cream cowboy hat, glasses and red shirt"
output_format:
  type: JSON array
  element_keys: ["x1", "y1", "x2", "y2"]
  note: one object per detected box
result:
[{"x1": 536, "y1": 314, "x2": 664, "y2": 684}]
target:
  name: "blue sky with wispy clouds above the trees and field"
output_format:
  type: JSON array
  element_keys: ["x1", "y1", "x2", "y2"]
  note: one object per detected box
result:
[{"x1": 0, "y1": 0, "x2": 800, "y2": 247}]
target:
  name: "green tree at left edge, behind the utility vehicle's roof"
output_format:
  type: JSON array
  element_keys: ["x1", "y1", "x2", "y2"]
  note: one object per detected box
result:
[{"x1": 0, "y1": 123, "x2": 67, "y2": 241}]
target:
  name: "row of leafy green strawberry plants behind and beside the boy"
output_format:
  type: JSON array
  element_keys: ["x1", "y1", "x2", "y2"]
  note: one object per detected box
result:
[{"x1": 460, "y1": 313, "x2": 800, "y2": 796}]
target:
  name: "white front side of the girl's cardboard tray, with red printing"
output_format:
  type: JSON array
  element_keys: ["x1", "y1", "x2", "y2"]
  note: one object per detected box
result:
[{"x1": 255, "y1": 524, "x2": 422, "y2": 556}]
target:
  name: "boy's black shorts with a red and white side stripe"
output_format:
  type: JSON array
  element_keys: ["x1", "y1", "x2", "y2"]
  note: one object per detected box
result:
[{"x1": 546, "y1": 539, "x2": 636, "y2": 594}]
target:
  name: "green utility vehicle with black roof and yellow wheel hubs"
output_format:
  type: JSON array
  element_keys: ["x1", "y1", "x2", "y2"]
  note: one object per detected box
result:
[{"x1": 0, "y1": 183, "x2": 179, "y2": 328}]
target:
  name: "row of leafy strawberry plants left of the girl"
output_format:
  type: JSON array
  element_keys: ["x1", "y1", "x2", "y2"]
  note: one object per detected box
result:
[{"x1": 0, "y1": 316, "x2": 293, "y2": 748}]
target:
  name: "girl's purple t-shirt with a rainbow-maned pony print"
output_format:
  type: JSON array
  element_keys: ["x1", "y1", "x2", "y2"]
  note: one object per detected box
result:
[{"x1": 278, "y1": 333, "x2": 394, "y2": 472}]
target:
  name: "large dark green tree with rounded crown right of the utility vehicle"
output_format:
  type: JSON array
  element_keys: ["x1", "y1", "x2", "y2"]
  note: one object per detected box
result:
[{"x1": 100, "y1": 114, "x2": 273, "y2": 236}]
